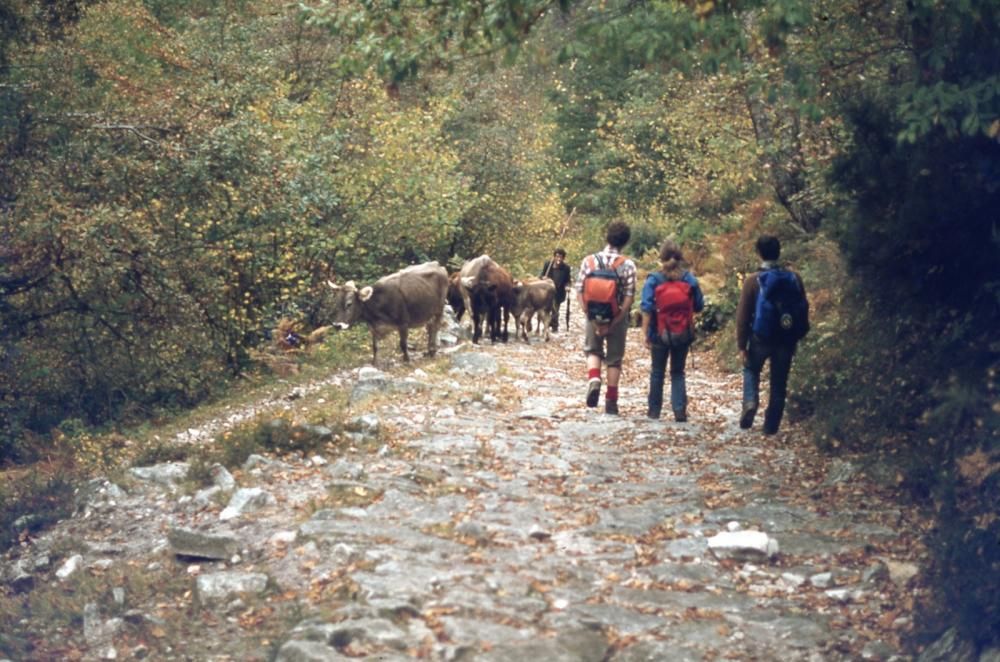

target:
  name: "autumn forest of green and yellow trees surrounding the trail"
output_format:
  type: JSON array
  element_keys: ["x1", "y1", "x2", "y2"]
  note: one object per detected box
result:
[{"x1": 0, "y1": 0, "x2": 1000, "y2": 646}]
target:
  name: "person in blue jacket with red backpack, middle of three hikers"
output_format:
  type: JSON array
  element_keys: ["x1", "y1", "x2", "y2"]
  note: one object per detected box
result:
[{"x1": 639, "y1": 241, "x2": 705, "y2": 423}]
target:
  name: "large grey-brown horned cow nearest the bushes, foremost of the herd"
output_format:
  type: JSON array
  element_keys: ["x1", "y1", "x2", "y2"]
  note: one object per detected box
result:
[{"x1": 329, "y1": 262, "x2": 448, "y2": 363}]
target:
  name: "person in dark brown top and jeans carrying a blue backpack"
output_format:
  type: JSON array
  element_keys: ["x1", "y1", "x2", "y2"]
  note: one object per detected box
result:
[{"x1": 736, "y1": 235, "x2": 809, "y2": 434}]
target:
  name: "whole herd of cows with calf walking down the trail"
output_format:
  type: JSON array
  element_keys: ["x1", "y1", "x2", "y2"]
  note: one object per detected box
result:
[{"x1": 327, "y1": 255, "x2": 555, "y2": 361}]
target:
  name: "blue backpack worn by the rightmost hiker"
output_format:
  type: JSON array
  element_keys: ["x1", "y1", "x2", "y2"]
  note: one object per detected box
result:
[{"x1": 752, "y1": 269, "x2": 809, "y2": 344}]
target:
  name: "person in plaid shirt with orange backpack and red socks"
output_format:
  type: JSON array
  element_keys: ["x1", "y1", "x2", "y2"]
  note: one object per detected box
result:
[{"x1": 575, "y1": 221, "x2": 636, "y2": 414}]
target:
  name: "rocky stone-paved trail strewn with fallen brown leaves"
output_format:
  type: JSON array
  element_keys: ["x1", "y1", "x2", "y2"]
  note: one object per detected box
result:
[{"x1": 2, "y1": 318, "x2": 922, "y2": 662}]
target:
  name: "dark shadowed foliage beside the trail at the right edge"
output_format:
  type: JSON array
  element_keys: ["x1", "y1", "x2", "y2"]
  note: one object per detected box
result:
[{"x1": 821, "y1": 2, "x2": 1000, "y2": 642}]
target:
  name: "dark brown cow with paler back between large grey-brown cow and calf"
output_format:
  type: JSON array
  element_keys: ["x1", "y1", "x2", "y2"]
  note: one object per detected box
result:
[{"x1": 459, "y1": 255, "x2": 514, "y2": 343}]
